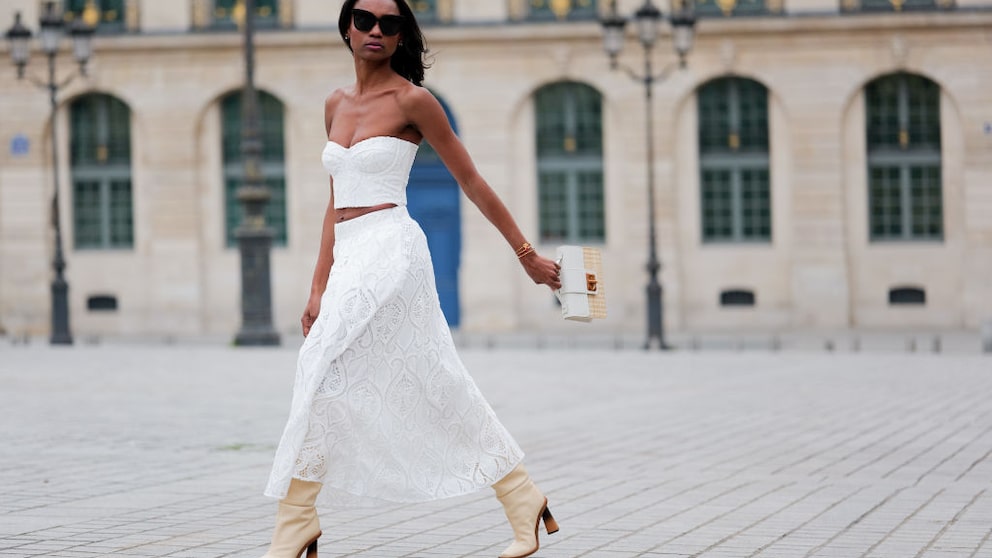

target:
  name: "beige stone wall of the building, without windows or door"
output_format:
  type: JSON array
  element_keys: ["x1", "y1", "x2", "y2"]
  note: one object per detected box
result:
[{"x1": 0, "y1": 0, "x2": 992, "y2": 342}]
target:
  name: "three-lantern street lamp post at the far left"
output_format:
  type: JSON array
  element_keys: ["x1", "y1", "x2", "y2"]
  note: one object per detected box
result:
[{"x1": 6, "y1": 2, "x2": 96, "y2": 345}]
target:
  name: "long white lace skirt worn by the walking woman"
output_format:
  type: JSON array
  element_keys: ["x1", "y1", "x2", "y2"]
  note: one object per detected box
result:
[{"x1": 265, "y1": 207, "x2": 523, "y2": 506}]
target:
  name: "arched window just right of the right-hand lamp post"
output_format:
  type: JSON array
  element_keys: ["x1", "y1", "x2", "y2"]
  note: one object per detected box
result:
[{"x1": 697, "y1": 78, "x2": 772, "y2": 242}]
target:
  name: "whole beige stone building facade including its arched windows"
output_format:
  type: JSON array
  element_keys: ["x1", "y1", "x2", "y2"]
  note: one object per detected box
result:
[{"x1": 0, "y1": 0, "x2": 992, "y2": 337}]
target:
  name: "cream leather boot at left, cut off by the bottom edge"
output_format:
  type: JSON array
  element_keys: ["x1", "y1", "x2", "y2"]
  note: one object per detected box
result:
[{"x1": 262, "y1": 479, "x2": 321, "y2": 558}]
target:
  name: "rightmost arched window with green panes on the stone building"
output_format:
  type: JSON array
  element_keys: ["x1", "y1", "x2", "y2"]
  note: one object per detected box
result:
[{"x1": 865, "y1": 74, "x2": 944, "y2": 241}]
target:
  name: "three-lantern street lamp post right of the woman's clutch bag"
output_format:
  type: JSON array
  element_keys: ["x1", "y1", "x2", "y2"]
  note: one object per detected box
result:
[{"x1": 601, "y1": 0, "x2": 696, "y2": 349}]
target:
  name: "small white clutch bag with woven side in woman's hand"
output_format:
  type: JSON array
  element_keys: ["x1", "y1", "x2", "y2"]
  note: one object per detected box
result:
[{"x1": 555, "y1": 246, "x2": 606, "y2": 322}]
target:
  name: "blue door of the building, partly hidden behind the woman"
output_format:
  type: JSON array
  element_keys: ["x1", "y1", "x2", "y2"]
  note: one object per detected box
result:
[{"x1": 406, "y1": 95, "x2": 462, "y2": 327}]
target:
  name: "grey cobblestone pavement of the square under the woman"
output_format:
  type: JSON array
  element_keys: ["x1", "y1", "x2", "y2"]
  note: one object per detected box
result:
[{"x1": 0, "y1": 344, "x2": 992, "y2": 558}]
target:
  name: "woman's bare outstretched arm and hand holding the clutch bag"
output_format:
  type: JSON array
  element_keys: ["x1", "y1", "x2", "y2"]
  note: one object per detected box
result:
[{"x1": 400, "y1": 87, "x2": 561, "y2": 289}]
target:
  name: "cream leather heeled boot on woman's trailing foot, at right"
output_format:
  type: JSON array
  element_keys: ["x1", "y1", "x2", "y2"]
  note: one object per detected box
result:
[{"x1": 493, "y1": 463, "x2": 558, "y2": 558}]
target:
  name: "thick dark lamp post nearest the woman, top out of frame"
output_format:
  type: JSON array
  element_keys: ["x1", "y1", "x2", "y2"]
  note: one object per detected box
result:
[{"x1": 234, "y1": 0, "x2": 279, "y2": 346}]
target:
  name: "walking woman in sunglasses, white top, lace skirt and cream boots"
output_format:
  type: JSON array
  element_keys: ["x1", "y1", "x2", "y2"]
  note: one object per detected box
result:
[{"x1": 265, "y1": 0, "x2": 561, "y2": 558}]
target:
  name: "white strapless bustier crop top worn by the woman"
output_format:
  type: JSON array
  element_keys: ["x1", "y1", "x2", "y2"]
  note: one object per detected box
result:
[{"x1": 321, "y1": 136, "x2": 419, "y2": 209}]
